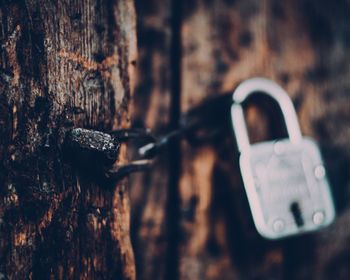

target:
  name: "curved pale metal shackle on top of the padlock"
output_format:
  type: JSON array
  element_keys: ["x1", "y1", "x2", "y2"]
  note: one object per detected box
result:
[{"x1": 231, "y1": 78, "x2": 302, "y2": 151}]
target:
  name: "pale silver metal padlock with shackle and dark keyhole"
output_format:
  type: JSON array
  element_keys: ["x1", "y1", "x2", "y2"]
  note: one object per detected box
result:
[{"x1": 231, "y1": 78, "x2": 335, "y2": 239}]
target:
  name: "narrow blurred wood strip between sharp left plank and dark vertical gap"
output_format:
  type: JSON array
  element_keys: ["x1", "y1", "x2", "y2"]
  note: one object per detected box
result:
[{"x1": 130, "y1": 0, "x2": 177, "y2": 279}]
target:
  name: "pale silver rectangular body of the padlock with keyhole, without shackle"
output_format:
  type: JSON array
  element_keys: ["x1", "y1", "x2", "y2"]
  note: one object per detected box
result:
[{"x1": 240, "y1": 137, "x2": 335, "y2": 239}]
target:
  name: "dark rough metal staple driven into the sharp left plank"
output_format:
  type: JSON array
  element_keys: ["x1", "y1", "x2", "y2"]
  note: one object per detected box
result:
[{"x1": 64, "y1": 128, "x2": 155, "y2": 184}]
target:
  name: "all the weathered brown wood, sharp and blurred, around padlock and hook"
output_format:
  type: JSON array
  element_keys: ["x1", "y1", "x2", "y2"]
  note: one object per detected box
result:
[{"x1": 0, "y1": 0, "x2": 350, "y2": 279}]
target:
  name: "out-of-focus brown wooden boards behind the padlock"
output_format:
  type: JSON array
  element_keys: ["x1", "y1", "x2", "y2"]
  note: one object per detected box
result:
[{"x1": 131, "y1": 0, "x2": 350, "y2": 280}]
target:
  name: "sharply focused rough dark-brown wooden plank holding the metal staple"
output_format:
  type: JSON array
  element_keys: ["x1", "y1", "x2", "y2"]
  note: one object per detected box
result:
[{"x1": 0, "y1": 0, "x2": 136, "y2": 279}]
